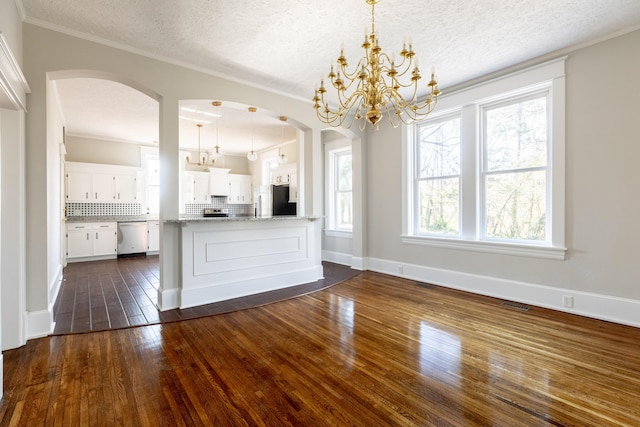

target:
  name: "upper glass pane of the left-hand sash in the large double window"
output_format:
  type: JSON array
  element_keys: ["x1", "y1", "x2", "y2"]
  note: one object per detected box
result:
[{"x1": 418, "y1": 117, "x2": 460, "y2": 178}]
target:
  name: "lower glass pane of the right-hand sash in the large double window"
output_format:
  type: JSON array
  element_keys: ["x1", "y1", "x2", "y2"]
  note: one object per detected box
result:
[{"x1": 485, "y1": 171, "x2": 547, "y2": 241}]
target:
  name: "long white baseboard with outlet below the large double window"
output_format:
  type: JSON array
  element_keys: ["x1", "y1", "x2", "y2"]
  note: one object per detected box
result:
[{"x1": 368, "y1": 258, "x2": 640, "y2": 327}]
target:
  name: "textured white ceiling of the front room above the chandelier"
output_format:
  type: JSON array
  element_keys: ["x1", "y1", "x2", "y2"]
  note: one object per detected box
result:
[{"x1": 22, "y1": 0, "x2": 640, "y2": 153}]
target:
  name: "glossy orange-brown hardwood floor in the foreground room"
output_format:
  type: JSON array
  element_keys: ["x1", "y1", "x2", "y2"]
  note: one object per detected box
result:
[{"x1": 0, "y1": 272, "x2": 640, "y2": 427}]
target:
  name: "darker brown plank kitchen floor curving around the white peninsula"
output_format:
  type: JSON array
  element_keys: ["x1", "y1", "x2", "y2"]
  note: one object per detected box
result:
[{"x1": 53, "y1": 255, "x2": 359, "y2": 335}]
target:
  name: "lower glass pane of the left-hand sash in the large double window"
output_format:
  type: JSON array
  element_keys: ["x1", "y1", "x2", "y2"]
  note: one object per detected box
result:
[{"x1": 418, "y1": 178, "x2": 460, "y2": 234}]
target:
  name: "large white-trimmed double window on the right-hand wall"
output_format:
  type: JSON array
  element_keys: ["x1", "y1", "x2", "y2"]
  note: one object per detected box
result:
[{"x1": 403, "y1": 60, "x2": 566, "y2": 259}]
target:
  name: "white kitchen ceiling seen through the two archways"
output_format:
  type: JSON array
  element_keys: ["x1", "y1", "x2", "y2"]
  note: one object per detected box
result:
[{"x1": 54, "y1": 78, "x2": 297, "y2": 156}]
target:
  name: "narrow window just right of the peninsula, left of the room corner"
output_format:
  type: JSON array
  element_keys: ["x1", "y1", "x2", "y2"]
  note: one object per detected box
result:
[{"x1": 326, "y1": 146, "x2": 353, "y2": 233}]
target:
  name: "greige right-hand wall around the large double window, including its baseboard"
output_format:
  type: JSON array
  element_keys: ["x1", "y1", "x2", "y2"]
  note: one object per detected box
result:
[{"x1": 368, "y1": 31, "x2": 640, "y2": 326}]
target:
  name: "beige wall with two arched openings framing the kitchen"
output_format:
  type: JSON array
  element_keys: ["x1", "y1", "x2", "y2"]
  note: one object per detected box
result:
[{"x1": 23, "y1": 24, "x2": 330, "y2": 332}]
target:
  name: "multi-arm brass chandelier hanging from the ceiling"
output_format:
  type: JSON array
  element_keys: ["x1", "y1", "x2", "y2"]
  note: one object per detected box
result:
[{"x1": 313, "y1": 0, "x2": 440, "y2": 131}]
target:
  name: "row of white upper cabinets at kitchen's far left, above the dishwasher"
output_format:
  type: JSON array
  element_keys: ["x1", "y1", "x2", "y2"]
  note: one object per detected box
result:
[{"x1": 65, "y1": 162, "x2": 138, "y2": 203}]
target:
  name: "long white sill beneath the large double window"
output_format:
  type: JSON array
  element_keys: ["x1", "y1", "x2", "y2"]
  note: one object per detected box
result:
[{"x1": 401, "y1": 236, "x2": 567, "y2": 261}]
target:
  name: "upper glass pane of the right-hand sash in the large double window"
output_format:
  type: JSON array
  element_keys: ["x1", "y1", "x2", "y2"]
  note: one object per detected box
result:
[{"x1": 485, "y1": 96, "x2": 548, "y2": 171}]
